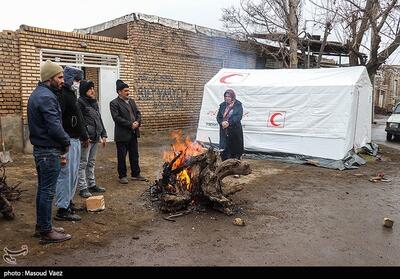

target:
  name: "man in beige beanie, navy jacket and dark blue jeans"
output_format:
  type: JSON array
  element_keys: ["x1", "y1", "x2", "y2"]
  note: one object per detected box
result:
[{"x1": 28, "y1": 60, "x2": 71, "y2": 244}]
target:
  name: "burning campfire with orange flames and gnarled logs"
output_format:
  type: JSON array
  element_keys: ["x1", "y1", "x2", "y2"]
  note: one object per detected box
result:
[{"x1": 150, "y1": 131, "x2": 251, "y2": 215}]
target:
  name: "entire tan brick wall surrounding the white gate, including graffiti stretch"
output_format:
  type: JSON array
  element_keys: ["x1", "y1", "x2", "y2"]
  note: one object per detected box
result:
[{"x1": 0, "y1": 20, "x2": 257, "y2": 147}]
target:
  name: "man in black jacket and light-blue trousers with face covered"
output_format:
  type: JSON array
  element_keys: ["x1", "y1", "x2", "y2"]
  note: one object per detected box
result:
[{"x1": 55, "y1": 66, "x2": 89, "y2": 221}]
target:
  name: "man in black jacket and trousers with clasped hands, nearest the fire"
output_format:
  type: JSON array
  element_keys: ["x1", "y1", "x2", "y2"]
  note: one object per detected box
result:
[{"x1": 110, "y1": 80, "x2": 147, "y2": 184}]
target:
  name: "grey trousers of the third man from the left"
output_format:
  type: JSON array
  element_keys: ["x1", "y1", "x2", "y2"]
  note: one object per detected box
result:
[{"x1": 78, "y1": 142, "x2": 99, "y2": 190}]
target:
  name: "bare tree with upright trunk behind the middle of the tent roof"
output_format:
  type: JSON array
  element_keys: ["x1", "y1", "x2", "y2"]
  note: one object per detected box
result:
[{"x1": 222, "y1": 0, "x2": 301, "y2": 68}]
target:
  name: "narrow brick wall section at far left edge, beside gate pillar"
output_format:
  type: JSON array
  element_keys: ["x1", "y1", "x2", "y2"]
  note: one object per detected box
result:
[{"x1": 0, "y1": 31, "x2": 21, "y2": 116}]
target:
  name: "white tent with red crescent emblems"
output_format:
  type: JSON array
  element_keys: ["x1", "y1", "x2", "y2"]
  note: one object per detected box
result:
[{"x1": 196, "y1": 66, "x2": 372, "y2": 160}]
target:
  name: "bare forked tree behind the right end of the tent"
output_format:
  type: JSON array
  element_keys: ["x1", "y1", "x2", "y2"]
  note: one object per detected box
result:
[{"x1": 311, "y1": 0, "x2": 400, "y2": 81}]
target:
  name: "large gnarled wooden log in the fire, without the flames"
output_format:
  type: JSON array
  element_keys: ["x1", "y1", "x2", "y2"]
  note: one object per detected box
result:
[{"x1": 151, "y1": 148, "x2": 251, "y2": 214}]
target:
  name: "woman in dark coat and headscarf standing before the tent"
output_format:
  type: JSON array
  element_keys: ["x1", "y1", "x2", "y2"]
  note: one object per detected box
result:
[{"x1": 217, "y1": 89, "x2": 243, "y2": 161}]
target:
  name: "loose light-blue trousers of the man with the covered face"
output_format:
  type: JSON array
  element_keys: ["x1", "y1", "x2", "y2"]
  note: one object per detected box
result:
[{"x1": 56, "y1": 138, "x2": 81, "y2": 209}]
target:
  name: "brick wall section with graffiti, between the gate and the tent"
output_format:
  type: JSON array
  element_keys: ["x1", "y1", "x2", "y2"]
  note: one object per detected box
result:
[{"x1": 128, "y1": 21, "x2": 256, "y2": 130}]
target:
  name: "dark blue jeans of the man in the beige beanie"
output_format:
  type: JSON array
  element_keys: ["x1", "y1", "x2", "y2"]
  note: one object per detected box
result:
[{"x1": 33, "y1": 146, "x2": 61, "y2": 234}]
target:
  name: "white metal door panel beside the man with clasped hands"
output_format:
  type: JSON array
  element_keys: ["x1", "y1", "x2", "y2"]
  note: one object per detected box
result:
[{"x1": 99, "y1": 67, "x2": 118, "y2": 141}]
